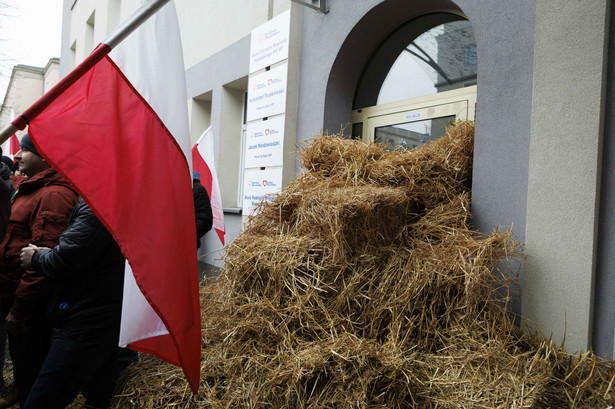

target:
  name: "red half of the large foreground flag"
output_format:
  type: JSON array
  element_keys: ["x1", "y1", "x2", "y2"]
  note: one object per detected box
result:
[{"x1": 29, "y1": 53, "x2": 201, "y2": 391}]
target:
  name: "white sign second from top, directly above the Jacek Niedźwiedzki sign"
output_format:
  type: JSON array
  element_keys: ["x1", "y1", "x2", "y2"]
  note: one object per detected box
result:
[{"x1": 247, "y1": 64, "x2": 288, "y2": 122}]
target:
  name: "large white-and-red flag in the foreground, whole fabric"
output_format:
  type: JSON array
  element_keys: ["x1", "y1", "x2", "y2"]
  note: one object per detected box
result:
[{"x1": 24, "y1": 2, "x2": 201, "y2": 392}]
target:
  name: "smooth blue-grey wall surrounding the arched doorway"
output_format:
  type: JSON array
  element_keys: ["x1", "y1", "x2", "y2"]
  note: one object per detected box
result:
[{"x1": 297, "y1": 0, "x2": 535, "y2": 312}]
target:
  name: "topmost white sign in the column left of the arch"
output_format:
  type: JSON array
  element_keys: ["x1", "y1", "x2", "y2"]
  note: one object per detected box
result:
[{"x1": 250, "y1": 10, "x2": 290, "y2": 74}]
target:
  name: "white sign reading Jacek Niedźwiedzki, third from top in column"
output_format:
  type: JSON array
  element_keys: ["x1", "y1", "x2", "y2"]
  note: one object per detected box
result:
[{"x1": 244, "y1": 116, "x2": 284, "y2": 169}]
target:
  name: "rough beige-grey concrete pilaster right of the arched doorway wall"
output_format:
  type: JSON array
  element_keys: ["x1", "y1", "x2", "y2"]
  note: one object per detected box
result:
[{"x1": 522, "y1": 0, "x2": 610, "y2": 351}]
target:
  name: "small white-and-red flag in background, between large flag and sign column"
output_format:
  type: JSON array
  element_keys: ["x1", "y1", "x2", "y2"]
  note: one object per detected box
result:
[{"x1": 192, "y1": 126, "x2": 226, "y2": 246}]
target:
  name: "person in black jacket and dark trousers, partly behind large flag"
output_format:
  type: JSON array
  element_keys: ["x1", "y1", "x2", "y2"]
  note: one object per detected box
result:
[{"x1": 21, "y1": 199, "x2": 125, "y2": 409}]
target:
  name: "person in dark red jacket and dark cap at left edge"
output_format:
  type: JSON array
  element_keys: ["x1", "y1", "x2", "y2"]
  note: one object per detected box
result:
[{"x1": 0, "y1": 134, "x2": 78, "y2": 405}]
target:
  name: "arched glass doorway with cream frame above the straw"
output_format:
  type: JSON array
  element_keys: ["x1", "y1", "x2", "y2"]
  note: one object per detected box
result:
[{"x1": 351, "y1": 13, "x2": 478, "y2": 148}]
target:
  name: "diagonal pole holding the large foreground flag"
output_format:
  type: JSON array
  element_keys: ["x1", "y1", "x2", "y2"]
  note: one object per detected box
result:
[{"x1": 0, "y1": 0, "x2": 169, "y2": 145}]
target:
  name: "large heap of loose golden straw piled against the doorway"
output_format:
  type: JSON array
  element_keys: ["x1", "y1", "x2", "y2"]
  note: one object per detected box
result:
[{"x1": 114, "y1": 122, "x2": 615, "y2": 409}]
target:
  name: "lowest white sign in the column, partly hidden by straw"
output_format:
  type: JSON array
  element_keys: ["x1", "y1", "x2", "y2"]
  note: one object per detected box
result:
[{"x1": 242, "y1": 167, "x2": 282, "y2": 216}]
